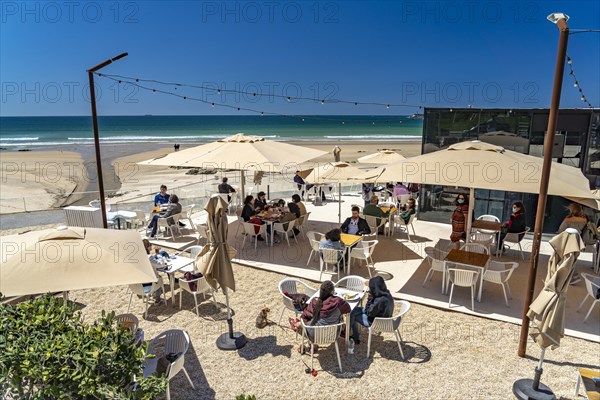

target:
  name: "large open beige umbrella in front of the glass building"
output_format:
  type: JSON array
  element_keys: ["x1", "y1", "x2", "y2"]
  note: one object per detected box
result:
[{"x1": 359, "y1": 140, "x2": 594, "y2": 231}]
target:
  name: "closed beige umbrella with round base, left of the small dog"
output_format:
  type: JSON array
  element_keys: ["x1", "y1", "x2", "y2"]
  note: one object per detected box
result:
[{"x1": 196, "y1": 195, "x2": 247, "y2": 350}]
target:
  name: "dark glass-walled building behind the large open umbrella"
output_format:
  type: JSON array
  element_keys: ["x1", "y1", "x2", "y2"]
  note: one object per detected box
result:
[{"x1": 419, "y1": 108, "x2": 600, "y2": 233}]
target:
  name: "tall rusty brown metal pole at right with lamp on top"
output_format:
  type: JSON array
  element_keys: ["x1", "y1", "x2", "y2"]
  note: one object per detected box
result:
[{"x1": 518, "y1": 17, "x2": 569, "y2": 357}]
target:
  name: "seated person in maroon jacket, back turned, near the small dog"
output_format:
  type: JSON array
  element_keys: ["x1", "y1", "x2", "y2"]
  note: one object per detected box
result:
[{"x1": 289, "y1": 281, "x2": 350, "y2": 337}]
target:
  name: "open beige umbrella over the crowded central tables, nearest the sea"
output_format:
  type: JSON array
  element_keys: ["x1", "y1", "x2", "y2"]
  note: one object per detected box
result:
[{"x1": 138, "y1": 133, "x2": 328, "y2": 196}]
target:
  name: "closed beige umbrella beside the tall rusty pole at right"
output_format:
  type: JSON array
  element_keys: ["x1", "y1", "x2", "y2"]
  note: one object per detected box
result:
[{"x1": 513, "y1": 228, "x2": 585, "y2": 398}]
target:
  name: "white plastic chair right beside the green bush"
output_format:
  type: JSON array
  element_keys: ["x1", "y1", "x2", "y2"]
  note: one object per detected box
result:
[{"x1": 144, "y1": 329, "x2": 196, "y2": 400}]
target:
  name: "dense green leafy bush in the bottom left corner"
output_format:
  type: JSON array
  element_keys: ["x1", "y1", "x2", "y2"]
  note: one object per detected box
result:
[{"x1": 0, "y1": 296, "x2": 167, "y2": 399}]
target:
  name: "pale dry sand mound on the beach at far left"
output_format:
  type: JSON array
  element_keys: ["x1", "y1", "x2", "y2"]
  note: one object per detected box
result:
[{"x1": 0, "y1": 151, "x2": 88, "y2": 214}]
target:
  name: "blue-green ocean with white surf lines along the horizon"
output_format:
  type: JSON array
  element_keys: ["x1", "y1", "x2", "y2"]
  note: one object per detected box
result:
[{"x1": 0, "y1": 115, "x2": 423, "y2": 150}]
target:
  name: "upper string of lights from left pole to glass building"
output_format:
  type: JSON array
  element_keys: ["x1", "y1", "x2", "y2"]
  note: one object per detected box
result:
[{"x1": 97, "y1": 73, "x2": 421, "y2": 109}]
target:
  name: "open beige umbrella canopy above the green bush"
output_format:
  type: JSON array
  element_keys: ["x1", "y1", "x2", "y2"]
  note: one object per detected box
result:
[{"x1": 0, "y1": 227, "x2": 156, "y2": 296}]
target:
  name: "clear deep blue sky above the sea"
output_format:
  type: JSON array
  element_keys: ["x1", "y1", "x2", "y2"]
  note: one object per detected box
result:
[{"x1": 0, "y1": 0, "x2": 600, "y2": 116}]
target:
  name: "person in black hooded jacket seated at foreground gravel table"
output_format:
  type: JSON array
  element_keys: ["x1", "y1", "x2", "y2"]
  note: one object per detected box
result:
[{"x1": 350, "y1": 276, "x2": 394, "y2": 344}]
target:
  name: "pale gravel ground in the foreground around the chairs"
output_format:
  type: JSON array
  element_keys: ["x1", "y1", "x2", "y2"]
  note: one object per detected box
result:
[{"x1": 0, "y1": 227, "x2": 600, "y2": 400}]
